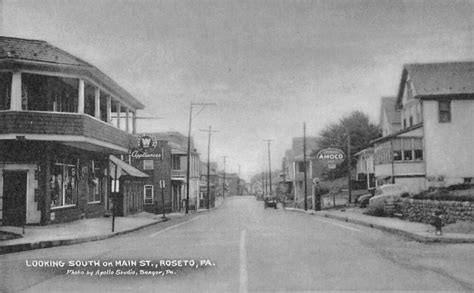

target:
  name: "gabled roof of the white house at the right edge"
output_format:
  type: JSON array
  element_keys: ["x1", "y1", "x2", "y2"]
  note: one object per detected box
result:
[{"x1": 397, "y1": 61, "x2": 474, "y2": 104}]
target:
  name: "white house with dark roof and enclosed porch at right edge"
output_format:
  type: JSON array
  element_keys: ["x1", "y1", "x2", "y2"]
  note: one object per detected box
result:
[{"x1": 373, "y1": 62, "x2": 474, "y2": 193}]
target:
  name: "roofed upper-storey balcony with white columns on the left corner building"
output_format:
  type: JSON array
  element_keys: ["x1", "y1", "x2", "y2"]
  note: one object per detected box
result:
[{"x1": 0, "y1": 36, "x2": 144, "y2": 154}]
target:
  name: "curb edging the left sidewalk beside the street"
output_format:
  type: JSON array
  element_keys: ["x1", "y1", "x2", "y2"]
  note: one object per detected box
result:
[{"x1": 0, "y1": 219, "x2": 164, "y2": 255}]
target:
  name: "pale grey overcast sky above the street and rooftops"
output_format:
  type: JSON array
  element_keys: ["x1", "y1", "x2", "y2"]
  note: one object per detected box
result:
[{"x1": 0, "y1": 0, "x2": 474, "y2": 178}]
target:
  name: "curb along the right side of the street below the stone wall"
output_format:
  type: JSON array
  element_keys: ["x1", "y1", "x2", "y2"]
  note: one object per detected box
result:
[{"x1": 286, "y1": 208, "x2": 474, "y2": 244}]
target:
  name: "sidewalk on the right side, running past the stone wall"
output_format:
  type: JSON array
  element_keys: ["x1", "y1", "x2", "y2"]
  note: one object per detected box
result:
[{"x1": 286, "y1": 207, "x2": 474, "y2": 243}]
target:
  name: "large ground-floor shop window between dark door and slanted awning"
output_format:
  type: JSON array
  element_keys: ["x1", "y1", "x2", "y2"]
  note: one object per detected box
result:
[{"x1": 50, "y1": 161, "x2": 77, "y2": 207}]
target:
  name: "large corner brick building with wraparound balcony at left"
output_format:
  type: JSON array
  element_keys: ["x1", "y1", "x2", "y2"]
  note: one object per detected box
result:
[{"x1": 0, "y1": 37, "x2": 144, "y2": 225}]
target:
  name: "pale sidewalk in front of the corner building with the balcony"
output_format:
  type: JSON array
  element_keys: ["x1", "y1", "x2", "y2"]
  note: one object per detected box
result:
[{"x1": 0, "y1": 212, "x2": 184, "y2": 254}]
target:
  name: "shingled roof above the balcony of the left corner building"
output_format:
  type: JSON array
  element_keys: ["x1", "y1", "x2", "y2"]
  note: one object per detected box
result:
[{"x1": 0, "y1": 36, "x2": 144, "y2": 109}]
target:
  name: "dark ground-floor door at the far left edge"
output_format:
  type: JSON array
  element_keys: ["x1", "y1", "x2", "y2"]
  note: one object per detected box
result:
[{"x1": 3, "y1": 171, "x2": 27, "y2": 226}]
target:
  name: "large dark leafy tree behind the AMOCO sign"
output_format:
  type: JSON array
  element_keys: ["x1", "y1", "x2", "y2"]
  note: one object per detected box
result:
[{"x1": 318, "y1": 111, "x2": 381, "y2": 178}]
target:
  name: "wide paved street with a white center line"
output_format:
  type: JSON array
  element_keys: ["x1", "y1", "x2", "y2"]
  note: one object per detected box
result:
[{"x1": 0, "y1": 197, "x2": 474, "y2": 292}]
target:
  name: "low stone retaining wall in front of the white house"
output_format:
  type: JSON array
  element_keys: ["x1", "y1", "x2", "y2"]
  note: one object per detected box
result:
[{"x1": 395, "y1": 198, "x2": 474, "y2": 224}]
